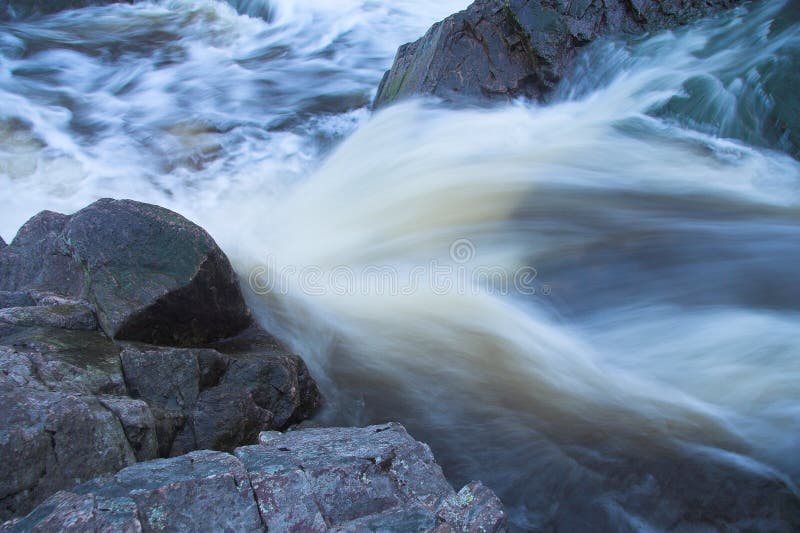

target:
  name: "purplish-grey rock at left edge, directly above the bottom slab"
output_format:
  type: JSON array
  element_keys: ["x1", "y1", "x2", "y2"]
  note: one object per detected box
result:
[{"x1": 0, "y1": 347, "x2": 135, "y2": 518}]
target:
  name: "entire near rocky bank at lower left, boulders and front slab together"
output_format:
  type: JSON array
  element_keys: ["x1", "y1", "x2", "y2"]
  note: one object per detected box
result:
[{"x1": 0, "y1": 199, "x2": 505, "y2": 531}]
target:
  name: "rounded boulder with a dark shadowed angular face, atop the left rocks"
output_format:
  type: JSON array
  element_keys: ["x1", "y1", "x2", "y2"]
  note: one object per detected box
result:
[{"x1": 66, "y1": 199, "x2": 252, "y2": 346}]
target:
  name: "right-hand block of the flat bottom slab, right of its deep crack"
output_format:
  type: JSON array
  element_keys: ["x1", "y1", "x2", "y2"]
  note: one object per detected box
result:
[{"x1": 241, "y1": 424, "x2": 505, "y2": 531}]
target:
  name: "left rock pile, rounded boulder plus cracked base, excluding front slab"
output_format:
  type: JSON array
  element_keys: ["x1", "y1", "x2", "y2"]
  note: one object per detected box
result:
[{"x1": 0, "y1": 200, "x2": 319, "y2": 519}]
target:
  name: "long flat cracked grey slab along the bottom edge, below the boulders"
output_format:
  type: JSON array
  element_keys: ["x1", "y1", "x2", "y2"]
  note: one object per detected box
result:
[{"x1": 0, "y1": 424, "x2": 506, "y2": 533}]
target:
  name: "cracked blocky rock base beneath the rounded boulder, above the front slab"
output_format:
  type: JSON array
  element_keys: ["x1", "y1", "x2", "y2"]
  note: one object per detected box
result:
[{"x1": 0, "y1": 322, "x2": 319, "y2": 519}]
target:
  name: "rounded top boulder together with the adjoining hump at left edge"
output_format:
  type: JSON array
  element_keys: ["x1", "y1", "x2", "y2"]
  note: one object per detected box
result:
[{"x1": 0, "y1": 199, "x2": 252, "y2": 346}]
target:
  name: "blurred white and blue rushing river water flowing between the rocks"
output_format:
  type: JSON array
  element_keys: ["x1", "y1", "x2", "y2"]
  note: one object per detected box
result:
[{"x1": 0, "y1": 0, "x2": 800, "y2": 531}]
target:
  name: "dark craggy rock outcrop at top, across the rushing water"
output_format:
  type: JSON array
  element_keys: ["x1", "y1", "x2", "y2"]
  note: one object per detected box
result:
[{"x1": 374, "y1": 0, "x2": 741, "y2": 108}]
